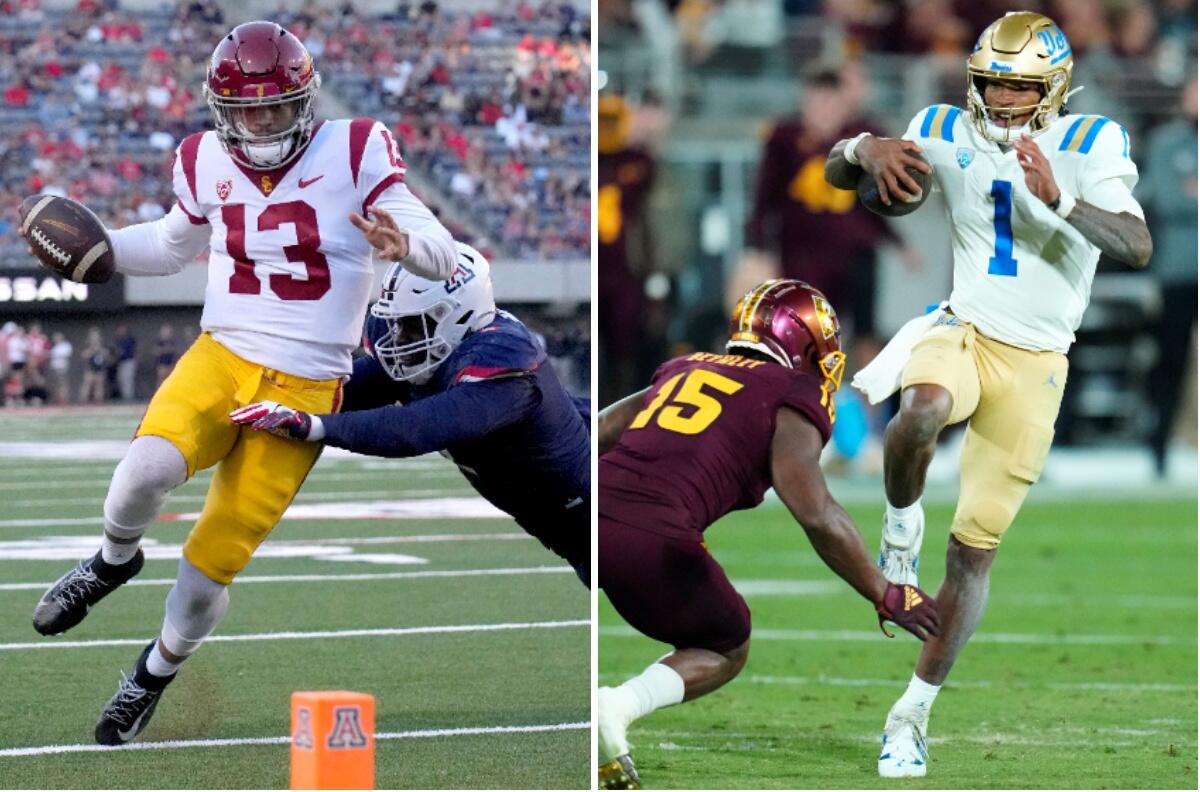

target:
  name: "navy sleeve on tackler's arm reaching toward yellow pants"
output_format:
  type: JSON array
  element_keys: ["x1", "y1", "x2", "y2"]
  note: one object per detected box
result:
[{"x1": 320, "y1": 376, "x2": 540, "y2": 457}]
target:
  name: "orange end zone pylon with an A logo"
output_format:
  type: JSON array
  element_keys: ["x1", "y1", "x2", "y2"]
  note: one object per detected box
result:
[{"x1": 292, "y1": 690, "x2": 374, "y2": 790}]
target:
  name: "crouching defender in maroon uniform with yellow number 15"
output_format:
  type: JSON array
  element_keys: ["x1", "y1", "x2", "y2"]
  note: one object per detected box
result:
[{"x1": 596, "y1": 280, "x2": 938, "y2": 788}]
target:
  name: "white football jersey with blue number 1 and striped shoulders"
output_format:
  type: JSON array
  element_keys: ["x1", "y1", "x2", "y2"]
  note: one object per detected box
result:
[{"x1": 904, "y1": 104, "x2": 1144, "y2": 353}]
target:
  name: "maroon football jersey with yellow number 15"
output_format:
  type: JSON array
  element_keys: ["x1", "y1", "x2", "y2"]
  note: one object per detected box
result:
[{"x1": 600, "y1": 352, "x2": 833, "y2": 535}]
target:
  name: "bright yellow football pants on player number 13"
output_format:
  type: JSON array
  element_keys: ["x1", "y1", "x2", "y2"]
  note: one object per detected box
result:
[{"x1": 136, "y1": 334, "x2": 342, "y2": 584}]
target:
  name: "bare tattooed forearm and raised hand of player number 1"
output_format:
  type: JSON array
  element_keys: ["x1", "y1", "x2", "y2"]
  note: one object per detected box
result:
[{"x1": 1013, "y1": 134, "x2": 1154, "y2": 270}]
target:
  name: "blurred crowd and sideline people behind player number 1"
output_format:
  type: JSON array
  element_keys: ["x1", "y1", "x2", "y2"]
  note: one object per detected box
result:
[{"x1": 596, "y1": 0, "x2": 1196, "y2": 472}]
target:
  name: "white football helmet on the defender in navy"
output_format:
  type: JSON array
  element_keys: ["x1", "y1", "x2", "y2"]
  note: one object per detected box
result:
[{"x1": 365, "y1": 242, "x2": 496, "y2": 385}]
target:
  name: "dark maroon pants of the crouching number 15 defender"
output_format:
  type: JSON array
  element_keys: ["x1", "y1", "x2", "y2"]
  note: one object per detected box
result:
[{"x1": 599, "y1": 515, "x2": 750, "y2": 654}]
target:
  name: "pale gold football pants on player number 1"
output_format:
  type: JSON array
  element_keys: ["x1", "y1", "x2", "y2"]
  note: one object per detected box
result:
[{"x1": 902, "y1": 314, "x2": 1067, "y2": 550}]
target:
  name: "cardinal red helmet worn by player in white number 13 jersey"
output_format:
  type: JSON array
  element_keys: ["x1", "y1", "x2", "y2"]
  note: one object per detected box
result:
[{"x1": 204, "y1": 22, "x2": 320, "y2": 170}]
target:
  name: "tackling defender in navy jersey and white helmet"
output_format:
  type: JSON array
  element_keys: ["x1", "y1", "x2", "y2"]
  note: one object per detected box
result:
[{"x1": 230, "y1": 244, "x2": 592, "y2": 583}]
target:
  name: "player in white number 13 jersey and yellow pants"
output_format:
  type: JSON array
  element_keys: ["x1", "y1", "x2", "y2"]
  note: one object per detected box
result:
[{"x1": 34, "y1": 22, "x2": 457, "y2": 745}]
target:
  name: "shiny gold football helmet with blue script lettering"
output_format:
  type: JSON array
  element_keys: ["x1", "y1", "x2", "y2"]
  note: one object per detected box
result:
[{"x1": 967, "y1": 11, "x2": 1075, "y2": 143}]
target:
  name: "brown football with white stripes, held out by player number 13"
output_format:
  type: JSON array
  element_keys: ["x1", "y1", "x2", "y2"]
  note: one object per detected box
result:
[{"x1": 20, "y1": 196, "x2": 116, "y2": 283}]
